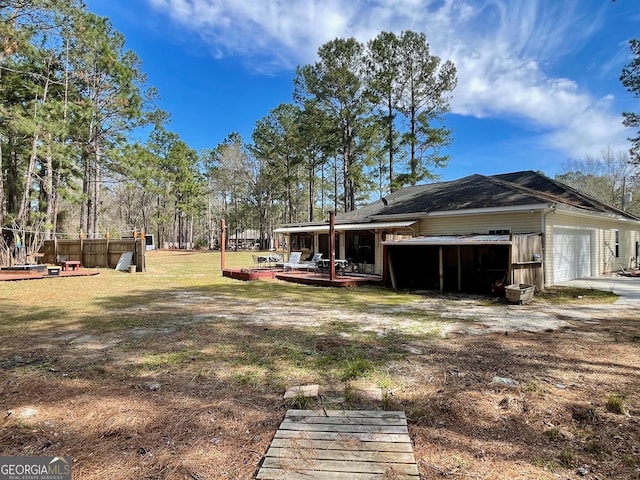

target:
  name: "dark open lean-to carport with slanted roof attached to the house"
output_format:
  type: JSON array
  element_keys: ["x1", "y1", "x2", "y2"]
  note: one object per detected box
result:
[{"x1": 382, "y1": 235, "x2": 512, "y2": 293}]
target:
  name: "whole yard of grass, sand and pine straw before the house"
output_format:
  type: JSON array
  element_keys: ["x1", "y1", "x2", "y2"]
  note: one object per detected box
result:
[{"x1": 0, "y1": 251, "x2": 640, "y2": 480}]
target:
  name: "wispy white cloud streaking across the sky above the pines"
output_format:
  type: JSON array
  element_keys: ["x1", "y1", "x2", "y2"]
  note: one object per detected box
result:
[{"x1": 149, "y1": 0, "x2": 628, "y2": 157}]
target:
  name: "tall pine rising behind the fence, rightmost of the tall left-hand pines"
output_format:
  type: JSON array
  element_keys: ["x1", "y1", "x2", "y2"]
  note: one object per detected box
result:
[{"x1": 70, "y1": 11, "x2": 158, "y2": 236}]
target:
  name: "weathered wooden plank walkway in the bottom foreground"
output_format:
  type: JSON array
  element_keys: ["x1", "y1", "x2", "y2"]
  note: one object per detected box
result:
[{"x1": 256, "y1": 410, "x2": 419, "y2": 480}]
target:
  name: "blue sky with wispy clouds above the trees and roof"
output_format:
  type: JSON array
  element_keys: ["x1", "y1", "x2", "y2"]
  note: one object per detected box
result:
[{"x1": 87, "y1": 0, "x2": 640, "y2": 180}]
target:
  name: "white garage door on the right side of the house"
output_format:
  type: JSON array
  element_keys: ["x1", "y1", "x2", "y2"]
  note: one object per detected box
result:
[{"x1": 553, "y1": 228, "x2": 591, "y2": 283}]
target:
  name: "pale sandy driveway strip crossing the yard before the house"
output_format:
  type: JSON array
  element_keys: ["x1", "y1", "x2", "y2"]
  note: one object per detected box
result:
[{"x1": 149, "y1": 284, "x2": 638, "y2": 336}]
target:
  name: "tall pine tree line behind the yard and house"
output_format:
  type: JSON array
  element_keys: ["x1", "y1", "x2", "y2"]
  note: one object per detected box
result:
[{"x1": 0, "y1": 0, "x2": 456, "y2": 263}]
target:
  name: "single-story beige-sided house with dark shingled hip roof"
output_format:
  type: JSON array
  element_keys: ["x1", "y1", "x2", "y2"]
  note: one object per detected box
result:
[{"x1": 275, "y1": 171, "x2": 640, "y2": 291}]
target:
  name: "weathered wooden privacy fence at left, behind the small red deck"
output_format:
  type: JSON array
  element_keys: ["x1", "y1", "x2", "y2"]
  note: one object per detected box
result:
[{"x1": 40, "y1": 238, "x2": 146, "y2": 272}]
